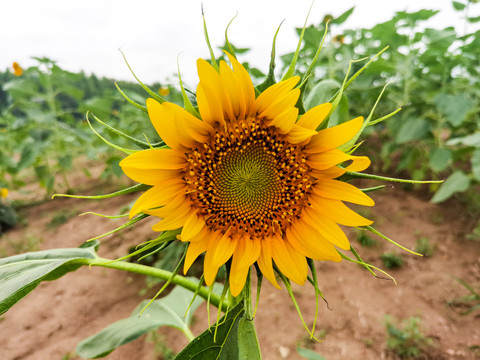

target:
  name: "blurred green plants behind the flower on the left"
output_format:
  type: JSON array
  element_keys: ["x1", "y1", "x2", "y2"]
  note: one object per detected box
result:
[{"x1": 0, "y1": 58, "x2": 181, "y2": 194}]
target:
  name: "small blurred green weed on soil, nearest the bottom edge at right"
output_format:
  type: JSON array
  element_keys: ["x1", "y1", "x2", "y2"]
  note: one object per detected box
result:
[{"x1": 385, "y1": 315, "x2": 434, "y2": 359}]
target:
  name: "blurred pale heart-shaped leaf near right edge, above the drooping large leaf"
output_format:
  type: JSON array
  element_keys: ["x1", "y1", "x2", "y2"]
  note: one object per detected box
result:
[{"x1": 433, "y1": 93, "x2": 475, "y2": 126}]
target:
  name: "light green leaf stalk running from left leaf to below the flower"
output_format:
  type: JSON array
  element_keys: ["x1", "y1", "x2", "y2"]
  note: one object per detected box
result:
[{"x1": 76, "y1": 257, "x2": 231, "y2": 312}]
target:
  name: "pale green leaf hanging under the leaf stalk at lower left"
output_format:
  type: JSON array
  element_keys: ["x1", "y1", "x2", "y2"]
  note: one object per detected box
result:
[{"x1": 76, "y1": 286, "x2": 204, "y2": 359}]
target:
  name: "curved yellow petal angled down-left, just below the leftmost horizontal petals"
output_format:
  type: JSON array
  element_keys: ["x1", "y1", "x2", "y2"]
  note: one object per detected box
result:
[{"x1": 129, "y1": 178, "x2": 185, "y2": 218}]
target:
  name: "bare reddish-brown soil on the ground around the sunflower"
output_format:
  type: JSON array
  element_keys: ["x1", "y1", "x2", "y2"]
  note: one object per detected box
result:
[{"x1": 0, "y1": 179, "x2": 480, "y2": 360}]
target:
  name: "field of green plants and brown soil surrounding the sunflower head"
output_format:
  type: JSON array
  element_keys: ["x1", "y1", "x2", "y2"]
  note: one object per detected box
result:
[{"x1": 0, "y1": 0, "x2": 480, "y2": 360}]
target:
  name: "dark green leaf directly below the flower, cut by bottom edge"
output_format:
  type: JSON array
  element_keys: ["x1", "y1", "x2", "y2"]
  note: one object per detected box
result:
[{"x1": 175, "y1": 301, "x2": 262, "y2": 360}]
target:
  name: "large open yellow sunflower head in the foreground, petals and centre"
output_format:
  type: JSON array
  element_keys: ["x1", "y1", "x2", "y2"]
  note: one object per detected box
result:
[{"x1": 120, "y1": 54, "x2": 374, "y2": 296}]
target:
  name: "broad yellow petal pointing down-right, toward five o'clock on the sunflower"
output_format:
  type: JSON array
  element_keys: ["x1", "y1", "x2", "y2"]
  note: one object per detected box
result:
[{"x1": 272, "y1": 236, "x2": 308, "y2": 285}]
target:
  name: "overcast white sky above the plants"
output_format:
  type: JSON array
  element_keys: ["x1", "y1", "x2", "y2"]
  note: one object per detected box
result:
[{"x1": 0, "y1": 0, "x2": 472, "y2": 84}]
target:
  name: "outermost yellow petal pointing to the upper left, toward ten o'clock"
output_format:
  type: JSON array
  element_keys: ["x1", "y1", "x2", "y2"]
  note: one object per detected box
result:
[{"x1": 147, "y1": 98, "x2": 181, "y2": 149}]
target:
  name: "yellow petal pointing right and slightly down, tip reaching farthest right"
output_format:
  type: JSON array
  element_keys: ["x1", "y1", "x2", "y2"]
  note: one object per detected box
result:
[{"x1": 313, "y1": 179, "x2": 375, "y2": 206}]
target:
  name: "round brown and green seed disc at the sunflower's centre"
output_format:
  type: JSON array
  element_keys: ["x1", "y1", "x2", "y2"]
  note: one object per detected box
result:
[{"x1": 185, "y1": 118, "x2": 314, "y2": 238}]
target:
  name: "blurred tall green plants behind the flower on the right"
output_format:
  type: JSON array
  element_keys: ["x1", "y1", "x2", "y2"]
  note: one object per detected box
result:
[{"x1": 281, "y1": 1, "x2": 480, "y2": 202}]
